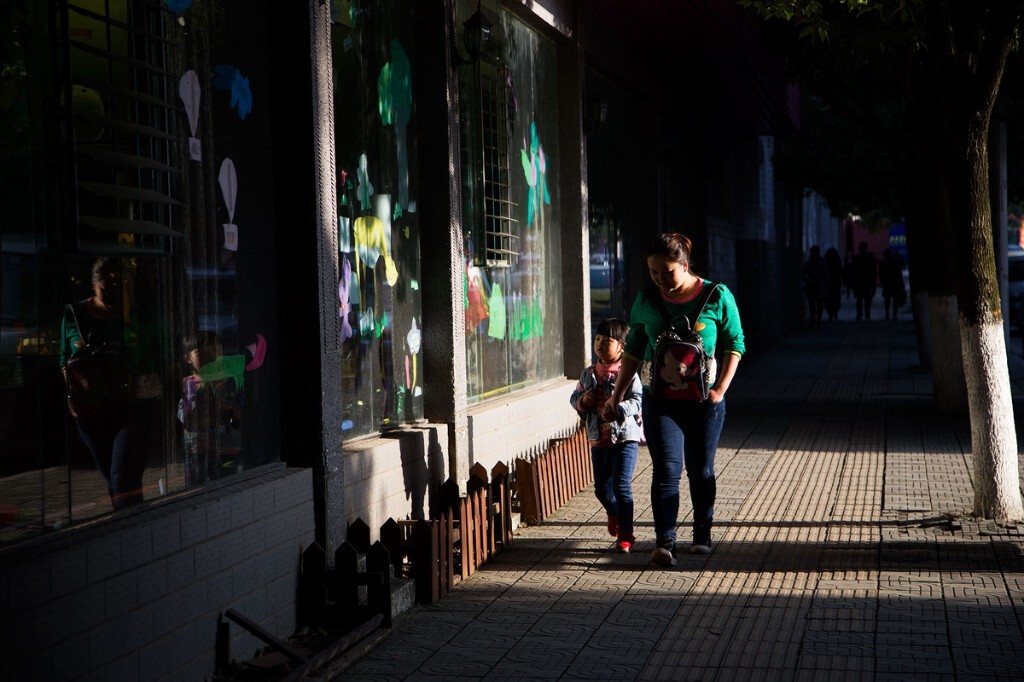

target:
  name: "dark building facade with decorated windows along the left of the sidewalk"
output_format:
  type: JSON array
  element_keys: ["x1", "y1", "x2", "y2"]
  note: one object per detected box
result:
[{"x1": 0, "y1": 0, "x2": 807, "y2": 680}]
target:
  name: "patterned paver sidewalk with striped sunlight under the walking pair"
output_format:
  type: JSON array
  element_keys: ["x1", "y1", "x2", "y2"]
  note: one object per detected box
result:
[{"x1": 342, "y1": 322, "x2": 1024, "y2": 681}]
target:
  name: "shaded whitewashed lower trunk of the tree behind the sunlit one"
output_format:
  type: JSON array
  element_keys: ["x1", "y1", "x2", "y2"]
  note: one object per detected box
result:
[{"x1": 928, "y1": 294, "x2": 968, "y2": 414}]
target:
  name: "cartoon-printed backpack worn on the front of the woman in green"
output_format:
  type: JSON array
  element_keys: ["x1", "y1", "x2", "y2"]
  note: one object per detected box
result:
[{"x1": 649, "y1": 282, "x2": 718, "y2": 400}]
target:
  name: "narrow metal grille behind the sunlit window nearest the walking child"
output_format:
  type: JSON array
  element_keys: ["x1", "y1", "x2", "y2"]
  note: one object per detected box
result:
[{"x1": 476, "y1": 59, "x2": 521, "y2": 267}]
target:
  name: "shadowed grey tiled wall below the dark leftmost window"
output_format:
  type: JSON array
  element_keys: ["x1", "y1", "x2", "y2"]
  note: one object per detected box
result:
[{"x1": 0, "y1": 468, "x2": 314, "y2": 682}]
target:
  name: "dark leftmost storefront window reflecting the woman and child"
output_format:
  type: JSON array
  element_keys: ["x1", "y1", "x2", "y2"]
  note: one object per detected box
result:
[{"x1": 0, "y1": 0, "x2": 279, "y2": 543}]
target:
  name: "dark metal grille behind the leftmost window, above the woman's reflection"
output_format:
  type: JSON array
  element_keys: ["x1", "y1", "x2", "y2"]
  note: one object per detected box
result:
[{"x1": 63, "y1": 0, "x2": 181, "y2": 244}]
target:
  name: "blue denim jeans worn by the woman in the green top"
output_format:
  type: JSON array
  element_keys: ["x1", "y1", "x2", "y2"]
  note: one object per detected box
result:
[{"x1": 643, "y1": 391, "x2": 725, "y2": 540}]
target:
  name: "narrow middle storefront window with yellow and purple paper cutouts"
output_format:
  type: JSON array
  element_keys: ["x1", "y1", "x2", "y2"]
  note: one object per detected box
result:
[{"x1": 332, "y1": 0, "x2": 423, "y2": 438}]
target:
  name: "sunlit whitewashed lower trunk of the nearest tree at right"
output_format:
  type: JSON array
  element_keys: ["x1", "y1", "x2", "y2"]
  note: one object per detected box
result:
[{"x1": 961, "y1": 318, "x2": 1024, "y2": 522}]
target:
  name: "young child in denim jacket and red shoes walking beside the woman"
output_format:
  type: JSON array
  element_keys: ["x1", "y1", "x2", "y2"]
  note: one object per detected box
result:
[{"x1": 569, "y1": 317, "x2": 643, "y2": 553}]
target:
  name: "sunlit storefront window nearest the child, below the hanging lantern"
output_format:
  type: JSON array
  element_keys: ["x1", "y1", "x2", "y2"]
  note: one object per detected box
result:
[{"x1": 460, "y1": 3, "x2": 562, "y2": 400}]
